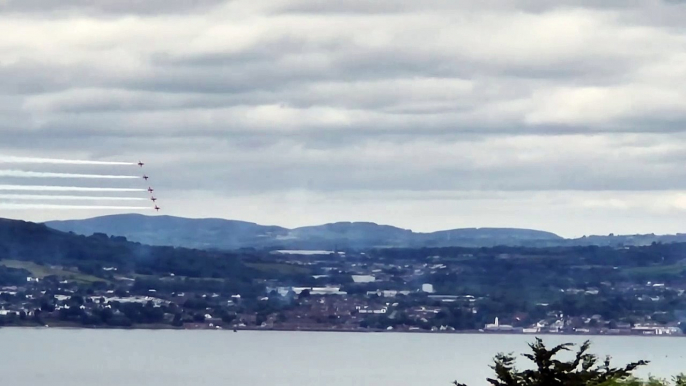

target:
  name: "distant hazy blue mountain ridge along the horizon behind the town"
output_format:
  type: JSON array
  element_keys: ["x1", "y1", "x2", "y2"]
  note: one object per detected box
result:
[{"x1": 46, "y1": 214, "x2": 564, "y2": 249}]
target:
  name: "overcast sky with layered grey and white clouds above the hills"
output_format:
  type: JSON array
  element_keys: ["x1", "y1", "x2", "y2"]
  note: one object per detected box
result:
[{"x1": 0, "y1": 0, "x2": 686, "y2": 236}]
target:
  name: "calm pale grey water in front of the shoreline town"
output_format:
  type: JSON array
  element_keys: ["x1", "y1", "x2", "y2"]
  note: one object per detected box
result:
[{"x1": 0, "y1": 328, "x2": 686, "y2": 386}]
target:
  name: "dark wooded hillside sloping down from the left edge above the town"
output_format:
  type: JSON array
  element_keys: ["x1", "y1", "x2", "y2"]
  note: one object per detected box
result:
[{"x1": 0, "y1": 218, "x2": 257, "y2": 286}]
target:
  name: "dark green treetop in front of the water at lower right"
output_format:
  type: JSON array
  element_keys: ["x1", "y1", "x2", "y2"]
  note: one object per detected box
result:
[{"x1": 454, "y1": 338, "x2": 648, "y2": 386}]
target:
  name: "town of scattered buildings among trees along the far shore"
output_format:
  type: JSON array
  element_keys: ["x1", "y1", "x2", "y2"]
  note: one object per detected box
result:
[{"x1": 0, "y1": 238, "x2": 686, "y2": 335}]
